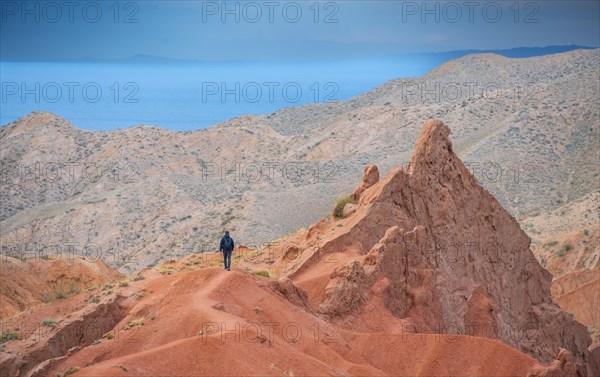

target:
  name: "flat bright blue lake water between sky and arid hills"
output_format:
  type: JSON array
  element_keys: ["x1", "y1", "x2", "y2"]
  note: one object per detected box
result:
[{"x1": 0, "y1": 46, "x2": 596, "y2": 131}]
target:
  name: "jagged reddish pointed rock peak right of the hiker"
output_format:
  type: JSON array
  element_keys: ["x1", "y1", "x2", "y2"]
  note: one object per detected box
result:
[{"x1": 278, "y1": 120, "x2": 590, "y2": 370}]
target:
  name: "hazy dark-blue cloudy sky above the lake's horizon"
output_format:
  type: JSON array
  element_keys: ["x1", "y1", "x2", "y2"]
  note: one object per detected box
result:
[{"x1": 0, "y1": 0, "x2": 600, "y2": 61}]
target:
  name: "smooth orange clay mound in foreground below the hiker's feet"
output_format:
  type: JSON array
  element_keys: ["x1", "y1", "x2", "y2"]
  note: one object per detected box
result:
[{"x1": 42, "y1": 268, "x2": 556, "y2": 376}]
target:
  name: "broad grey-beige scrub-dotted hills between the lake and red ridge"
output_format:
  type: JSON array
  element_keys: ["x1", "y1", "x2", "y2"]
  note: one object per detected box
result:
[{"x1": 0, "y1": 50, "x2": 600, "y2": 272}]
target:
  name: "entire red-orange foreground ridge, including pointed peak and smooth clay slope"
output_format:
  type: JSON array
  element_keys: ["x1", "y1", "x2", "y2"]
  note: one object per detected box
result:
[{"x1": 0, "y1": 121, "x2": 597, "y2": 377}]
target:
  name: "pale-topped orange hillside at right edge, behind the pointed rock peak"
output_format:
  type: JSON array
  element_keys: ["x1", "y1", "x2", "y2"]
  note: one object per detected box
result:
[{"x1": 523, "y1": 191, "x2": 600, "y2": 352}]
